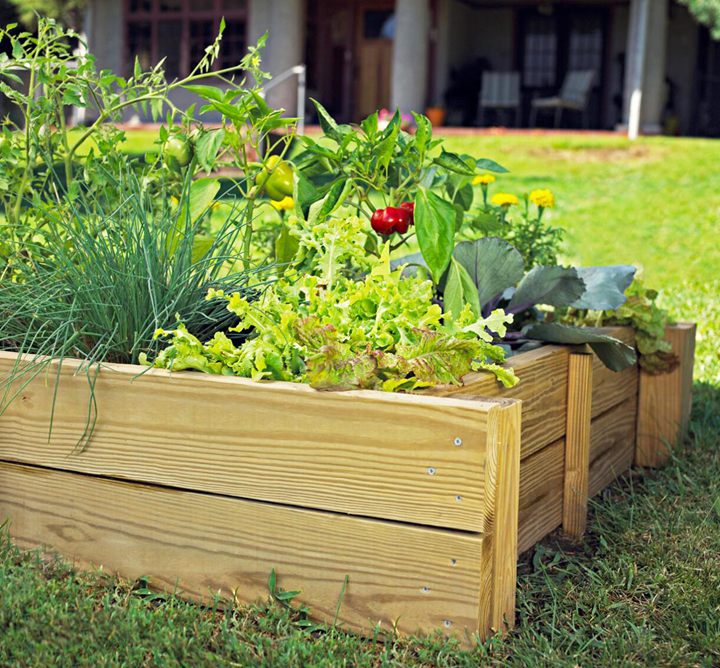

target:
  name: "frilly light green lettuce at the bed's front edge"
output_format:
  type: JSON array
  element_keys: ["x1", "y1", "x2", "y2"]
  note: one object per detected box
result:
[{"x1": 154, "y1": 224, "x2": 517, "y2": 391}]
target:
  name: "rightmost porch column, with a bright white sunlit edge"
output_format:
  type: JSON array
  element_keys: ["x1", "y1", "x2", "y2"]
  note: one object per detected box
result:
[{"x1": 623, "y1": 0, "x2": 668, "y2": 138}]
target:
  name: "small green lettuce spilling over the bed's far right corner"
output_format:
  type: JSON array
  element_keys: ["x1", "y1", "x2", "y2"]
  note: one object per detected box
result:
[{"x1": 562, "y1": 279, "x2": 678, "y2": 374}]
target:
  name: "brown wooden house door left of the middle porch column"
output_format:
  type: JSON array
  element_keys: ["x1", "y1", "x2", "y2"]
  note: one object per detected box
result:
[{"x1": 353, "y1": 2, "x2": 395, "y2": 119}]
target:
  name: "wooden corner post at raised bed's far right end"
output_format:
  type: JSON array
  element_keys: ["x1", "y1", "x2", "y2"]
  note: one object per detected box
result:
[{"x1": 635, "y1": 323, "x2": 696, "y2": 466}]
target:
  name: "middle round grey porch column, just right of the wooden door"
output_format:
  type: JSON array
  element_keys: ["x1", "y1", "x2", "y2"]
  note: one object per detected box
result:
[{"x1": 392, "y1": 0, "x2": 430, "y2": 112}]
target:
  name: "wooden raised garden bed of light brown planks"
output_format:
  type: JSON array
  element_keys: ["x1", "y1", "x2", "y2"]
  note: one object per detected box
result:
[{"x1": 0, "y1": 320, "x2": 694, "y2": 641}]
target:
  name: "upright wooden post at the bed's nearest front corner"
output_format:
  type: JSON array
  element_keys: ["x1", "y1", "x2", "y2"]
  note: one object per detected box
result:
[{"x1": 479, "y1": 400, "x2": 521, "y2": 637}]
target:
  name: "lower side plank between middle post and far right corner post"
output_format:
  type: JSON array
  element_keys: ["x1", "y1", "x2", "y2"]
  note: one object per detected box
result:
[{"x1": 588, "y1": 397, "x2": 638, "y2": 496}]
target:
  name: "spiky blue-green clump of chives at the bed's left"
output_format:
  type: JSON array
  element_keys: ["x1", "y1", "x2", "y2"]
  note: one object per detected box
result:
[{"x1": 0, "y1": 171, "x2": 259, "y2": 370}]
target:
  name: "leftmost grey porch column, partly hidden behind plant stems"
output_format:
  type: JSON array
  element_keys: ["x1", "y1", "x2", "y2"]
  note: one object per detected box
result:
[{"x1": 248, "y1": 0, "x2": 305, "y2": 116}]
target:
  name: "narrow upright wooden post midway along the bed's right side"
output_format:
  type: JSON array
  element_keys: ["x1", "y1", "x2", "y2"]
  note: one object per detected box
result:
[{"x1": 563, "y1": 353, "x2": 593, "y2": 540}]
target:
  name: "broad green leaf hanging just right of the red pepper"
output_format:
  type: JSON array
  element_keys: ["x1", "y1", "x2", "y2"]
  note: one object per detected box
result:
[{"x1": 415, "y1": 188, "x2": 455, "y2": 283}]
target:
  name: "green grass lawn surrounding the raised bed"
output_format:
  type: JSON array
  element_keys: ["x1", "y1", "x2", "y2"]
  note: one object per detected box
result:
[{"x1": 0, "y1": 130, "x2": 720, "y2": 667}]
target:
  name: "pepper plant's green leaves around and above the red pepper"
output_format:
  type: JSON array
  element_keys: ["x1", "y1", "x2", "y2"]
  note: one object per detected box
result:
[{"x1": 295, "y1": 102, "x2": 507, "y2": 268}]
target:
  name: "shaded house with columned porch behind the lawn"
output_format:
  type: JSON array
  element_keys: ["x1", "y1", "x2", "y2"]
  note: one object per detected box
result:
[{"x1": 86, "y1": 0, "x2": 720, "y2": 135}]
